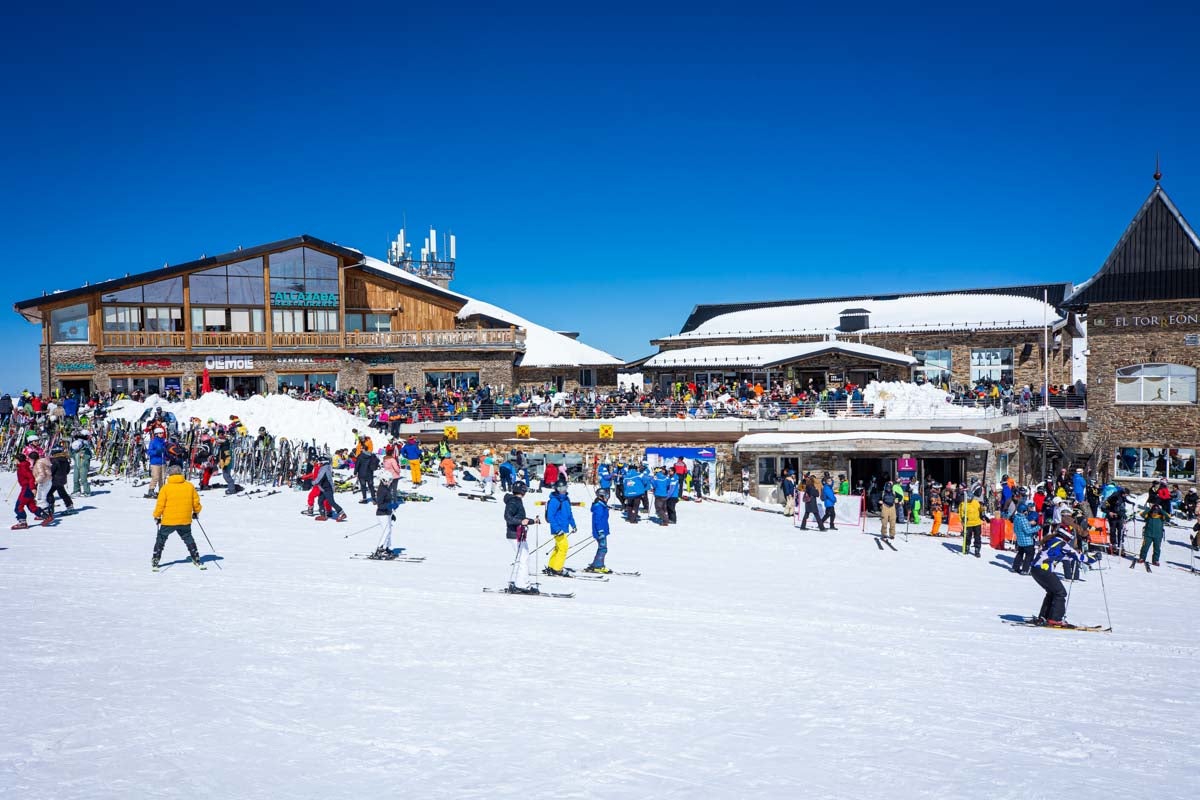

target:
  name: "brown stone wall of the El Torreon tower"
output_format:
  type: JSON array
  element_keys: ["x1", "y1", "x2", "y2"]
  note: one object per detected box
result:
[{"x1": 1087, "y1": 300, "x2": 1200, "y2": 483}]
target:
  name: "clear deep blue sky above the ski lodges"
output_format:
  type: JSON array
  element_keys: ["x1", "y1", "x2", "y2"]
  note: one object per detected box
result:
[{"x1": 0, "y1": 2, "x2": 1200, "y2": 390}]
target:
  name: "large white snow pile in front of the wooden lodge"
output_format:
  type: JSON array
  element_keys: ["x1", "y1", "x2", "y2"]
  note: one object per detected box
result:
[{"x1": 108, "y1": 392, "x2": 367, "y2": 449}]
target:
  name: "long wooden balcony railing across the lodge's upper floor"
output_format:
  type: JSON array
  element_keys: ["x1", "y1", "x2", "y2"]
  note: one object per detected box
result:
[{"x1": 102, "y1": 327, "x2": 526, "y2": 351}]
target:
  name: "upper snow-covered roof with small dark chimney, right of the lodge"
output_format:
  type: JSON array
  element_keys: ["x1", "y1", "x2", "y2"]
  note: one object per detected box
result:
[{"x1": 664, "y1": 293, "x2": 1062, "y2": 341}]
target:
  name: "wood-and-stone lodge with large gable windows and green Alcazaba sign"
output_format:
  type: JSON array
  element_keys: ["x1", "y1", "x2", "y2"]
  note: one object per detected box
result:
[{"x1": 14, "y1": 236, "x2": 620, "y2": 395}]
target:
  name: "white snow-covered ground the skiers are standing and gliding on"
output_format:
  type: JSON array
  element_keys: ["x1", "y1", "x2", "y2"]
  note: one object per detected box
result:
[{"x1": 0, "y1": 474, "x2": 1200, "y2": 800}]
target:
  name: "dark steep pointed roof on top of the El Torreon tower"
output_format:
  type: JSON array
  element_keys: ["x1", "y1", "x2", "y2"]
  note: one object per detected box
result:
[{"x1": 1063, "y1": 184, "x2": 1200, "y2": 308}]
